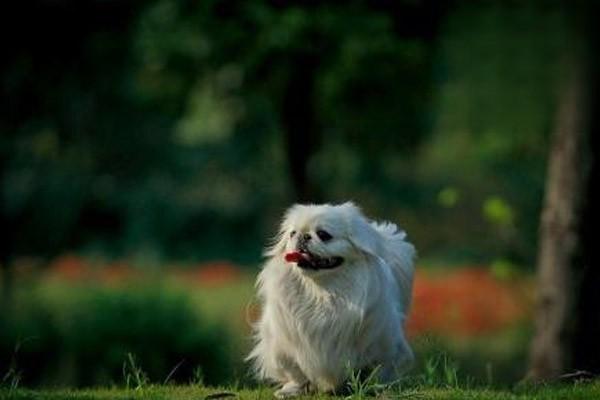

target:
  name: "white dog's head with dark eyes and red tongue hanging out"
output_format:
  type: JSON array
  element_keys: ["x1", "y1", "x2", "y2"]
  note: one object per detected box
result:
[{"x1": 266, "y1": 202, "x2": 379, "y2": 271}]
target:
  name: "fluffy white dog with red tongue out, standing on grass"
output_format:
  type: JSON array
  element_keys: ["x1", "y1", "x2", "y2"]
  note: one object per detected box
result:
[{"x1": 248, "y1": 203, "x2": 415, "y2": 398}]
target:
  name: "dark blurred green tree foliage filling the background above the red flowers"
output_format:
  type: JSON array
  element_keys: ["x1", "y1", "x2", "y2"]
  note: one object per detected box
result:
[{"x1": 0, "y1": 0, "x2": 568, "y2": 265}]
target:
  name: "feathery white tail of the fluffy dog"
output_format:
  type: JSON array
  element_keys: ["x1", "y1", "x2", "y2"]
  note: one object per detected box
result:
[{"x1": 371, "y1": 222, "x2": 416, "y2": 315}]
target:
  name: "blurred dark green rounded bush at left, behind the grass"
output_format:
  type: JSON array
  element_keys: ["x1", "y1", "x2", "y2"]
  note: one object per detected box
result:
[{"x1": 0, "y1": 284, "x2": 233, "y2": 386}]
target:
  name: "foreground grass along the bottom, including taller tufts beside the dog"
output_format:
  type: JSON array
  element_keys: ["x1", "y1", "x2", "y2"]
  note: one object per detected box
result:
[{"x1": 0, "y1": 353, "x2": 600, "y2": 400}]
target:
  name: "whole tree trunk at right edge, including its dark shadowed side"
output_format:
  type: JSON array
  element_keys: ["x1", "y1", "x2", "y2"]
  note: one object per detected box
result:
[{"x1": 527, "y1": 9, "x2": 600, "y2": 381}]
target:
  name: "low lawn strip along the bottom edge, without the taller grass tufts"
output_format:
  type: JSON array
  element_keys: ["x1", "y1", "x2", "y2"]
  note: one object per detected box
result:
[{"x1": 0, "y1": 382, "x2": 600, "y2": 400}]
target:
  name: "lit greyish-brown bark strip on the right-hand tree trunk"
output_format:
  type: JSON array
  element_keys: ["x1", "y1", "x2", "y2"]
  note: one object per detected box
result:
[{"x1": 528, "y1": 65, "x2": 589, "y2": 380}]
